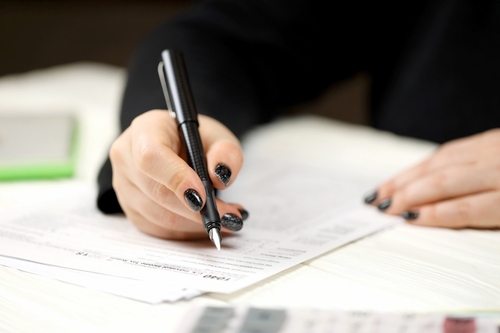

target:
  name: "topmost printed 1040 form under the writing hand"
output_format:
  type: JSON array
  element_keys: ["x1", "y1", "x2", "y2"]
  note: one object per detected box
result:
[{"x1": 0, "y1": 161, "x2": 400, "y2": 293}]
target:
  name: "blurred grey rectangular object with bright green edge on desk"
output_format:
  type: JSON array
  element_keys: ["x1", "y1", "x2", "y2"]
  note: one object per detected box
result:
[{"x1": 0, "y1": 113, "x2": 78, "y2": 181}]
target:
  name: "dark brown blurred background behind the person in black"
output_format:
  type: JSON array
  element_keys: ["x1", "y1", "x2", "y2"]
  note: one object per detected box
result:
[{"x1": 0, "y1": 0, "x2": 369, "y2": 124}]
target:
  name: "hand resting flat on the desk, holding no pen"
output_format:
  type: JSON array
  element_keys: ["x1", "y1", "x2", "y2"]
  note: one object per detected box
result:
[{"x1": 365, "y1": 129, "x2": 500, "y2": 228}]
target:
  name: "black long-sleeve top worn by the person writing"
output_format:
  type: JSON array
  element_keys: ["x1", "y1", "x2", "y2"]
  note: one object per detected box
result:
[{"x1": 98, "y1": 0, "x2": 500, "y2": 213}]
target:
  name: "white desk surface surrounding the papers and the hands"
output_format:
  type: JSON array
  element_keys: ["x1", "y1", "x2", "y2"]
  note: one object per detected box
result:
[{"x1": 0, "y1": 63, "x2": 500, "y2": 332}]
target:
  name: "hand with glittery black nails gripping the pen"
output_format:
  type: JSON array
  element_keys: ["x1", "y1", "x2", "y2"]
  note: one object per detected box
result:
[{"x1": 110, "y1": 110, "x2": 248, "y2": 239}]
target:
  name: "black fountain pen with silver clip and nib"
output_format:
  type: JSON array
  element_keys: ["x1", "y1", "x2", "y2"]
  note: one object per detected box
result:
[{"x1": 158, "y1": 50, "x2": 222, "y2": 251}]
